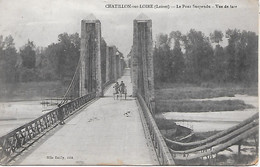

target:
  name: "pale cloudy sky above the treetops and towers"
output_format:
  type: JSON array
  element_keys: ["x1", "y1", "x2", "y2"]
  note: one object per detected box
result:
[{"x1": 0, "y1": 0, "x2": 258, "y2": 55}]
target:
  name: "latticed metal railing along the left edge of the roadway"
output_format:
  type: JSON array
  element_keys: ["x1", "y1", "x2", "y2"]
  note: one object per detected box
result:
[{"x1": 0, "y1": 92, "x2": 96, "y2": 164}]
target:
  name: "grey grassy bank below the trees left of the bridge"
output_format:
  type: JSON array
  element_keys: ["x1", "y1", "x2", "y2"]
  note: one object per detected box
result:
[{"x1": 0, "y1": 81, "x2": 67, "y2": 101}]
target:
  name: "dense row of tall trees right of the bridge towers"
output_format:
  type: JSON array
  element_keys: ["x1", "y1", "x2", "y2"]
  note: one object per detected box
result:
[{"x1": 153, "y1": 29, "x2": 258, "y2": 84}]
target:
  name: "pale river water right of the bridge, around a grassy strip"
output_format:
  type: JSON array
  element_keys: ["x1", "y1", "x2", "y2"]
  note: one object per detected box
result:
[{"x1": 162, "y1": 95, "x2": 258, "y2": 132}]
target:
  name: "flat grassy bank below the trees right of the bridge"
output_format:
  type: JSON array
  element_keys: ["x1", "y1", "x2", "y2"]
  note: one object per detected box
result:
[{"x1": 155, "y1": 83, "x2": 258, "y2": 100}]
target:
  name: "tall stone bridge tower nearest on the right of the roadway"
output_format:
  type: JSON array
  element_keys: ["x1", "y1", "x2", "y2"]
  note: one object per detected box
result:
[{"x1": 131, "y1": 14, "x2": 154, "y2": 112}]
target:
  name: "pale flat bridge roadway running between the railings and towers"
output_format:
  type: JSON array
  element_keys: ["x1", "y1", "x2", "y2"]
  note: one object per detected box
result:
[{"x1": 13, "y1": 70, "x2": 158, "y2": 165}]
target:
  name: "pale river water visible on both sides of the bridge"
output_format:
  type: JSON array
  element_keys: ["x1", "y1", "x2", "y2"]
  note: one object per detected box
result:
[{"x1": 0, "y1": 95, "x2": 258, "y2": 136}]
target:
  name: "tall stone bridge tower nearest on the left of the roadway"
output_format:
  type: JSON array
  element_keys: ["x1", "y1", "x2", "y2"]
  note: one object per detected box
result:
[{"x1": 79, "y1": 14, "x2": 103, "y2": 96}]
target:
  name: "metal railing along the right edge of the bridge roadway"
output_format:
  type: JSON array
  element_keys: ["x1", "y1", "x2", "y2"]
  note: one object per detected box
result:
[{"x1": 137, "y1": 94, "x2": 175, "y2": 165}]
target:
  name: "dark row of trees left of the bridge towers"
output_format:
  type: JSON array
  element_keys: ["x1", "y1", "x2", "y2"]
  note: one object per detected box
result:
[{"x1": 0, "y1": 33, "x2": 80, "y2": 83}]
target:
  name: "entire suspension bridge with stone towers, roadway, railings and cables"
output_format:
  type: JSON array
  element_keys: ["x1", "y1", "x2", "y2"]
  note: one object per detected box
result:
[{"x1": 0, "y1": 14, "x2": 259, "y2": 165}]
